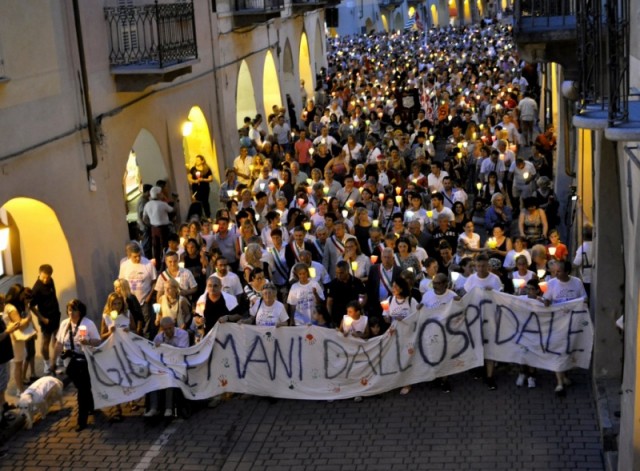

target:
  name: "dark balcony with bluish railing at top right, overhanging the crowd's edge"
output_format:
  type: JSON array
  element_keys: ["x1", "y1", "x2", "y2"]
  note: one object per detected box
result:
[{"x1": 513, "y1": 0, "x2": 580, "y2": 76}]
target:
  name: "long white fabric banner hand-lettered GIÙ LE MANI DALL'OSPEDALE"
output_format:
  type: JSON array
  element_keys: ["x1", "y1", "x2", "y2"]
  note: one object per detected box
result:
[{"x1": 84, "y1": 290, "x2": 593, "y2": 408}]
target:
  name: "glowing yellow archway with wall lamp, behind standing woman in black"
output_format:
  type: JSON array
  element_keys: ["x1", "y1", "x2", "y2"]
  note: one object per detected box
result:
[{"x1": 182, "y1": 106, "x2": 224, "y2": 218}]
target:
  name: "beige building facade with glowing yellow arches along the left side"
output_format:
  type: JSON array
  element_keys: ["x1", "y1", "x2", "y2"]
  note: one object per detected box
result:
[{"x1": 0, "y1": 0, "x2": 325, "y2": 316}]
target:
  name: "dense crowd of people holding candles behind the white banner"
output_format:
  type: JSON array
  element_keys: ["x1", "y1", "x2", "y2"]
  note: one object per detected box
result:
[{"x1": 0, "y1": 23, "x2": 591, "y2": 428}]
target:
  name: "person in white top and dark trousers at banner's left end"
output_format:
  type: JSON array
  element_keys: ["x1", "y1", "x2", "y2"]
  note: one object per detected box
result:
[{"x1": 54, "y1": 299, "x2": 101, "y2": 432}]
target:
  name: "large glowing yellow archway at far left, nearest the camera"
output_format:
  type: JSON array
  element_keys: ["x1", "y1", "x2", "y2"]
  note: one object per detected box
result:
[{"x1": 0, "y1": 198, "x2": 77, "y2": 306}]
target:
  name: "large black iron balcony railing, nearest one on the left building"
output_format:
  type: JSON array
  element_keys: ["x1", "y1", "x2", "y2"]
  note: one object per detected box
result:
[{"x1": 104, "y1": 0, "x2": 198, "y2": 69}]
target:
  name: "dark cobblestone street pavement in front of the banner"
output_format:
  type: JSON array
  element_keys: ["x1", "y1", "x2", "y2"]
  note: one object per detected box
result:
[{"x1": 0, "y1": 368, "x2": 603, "y2": 471}]
